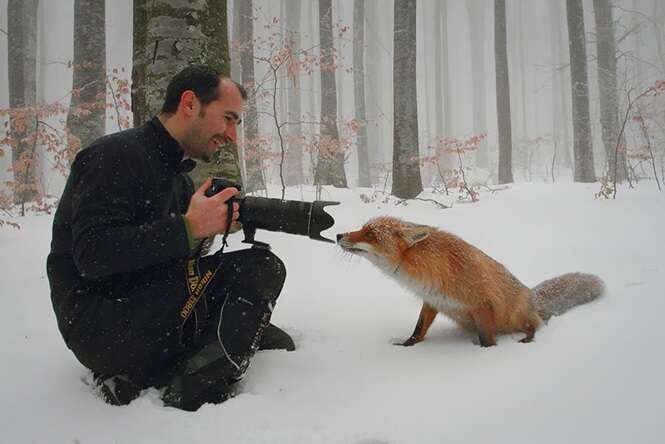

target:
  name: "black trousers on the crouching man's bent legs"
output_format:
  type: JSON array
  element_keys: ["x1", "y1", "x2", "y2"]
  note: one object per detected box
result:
[{"x1": 70, "y1": 248, "x2": 286, "y2": 387}]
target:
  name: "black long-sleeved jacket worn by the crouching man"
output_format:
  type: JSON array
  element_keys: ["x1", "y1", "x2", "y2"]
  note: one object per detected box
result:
[{"x1": 47, "y1": 118, "x2": 193, "y2": 354}]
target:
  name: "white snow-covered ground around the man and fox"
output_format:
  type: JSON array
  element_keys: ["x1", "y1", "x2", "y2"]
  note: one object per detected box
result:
[{"x1": 0, "y1": 182, "x2": 665, "y2": 444}]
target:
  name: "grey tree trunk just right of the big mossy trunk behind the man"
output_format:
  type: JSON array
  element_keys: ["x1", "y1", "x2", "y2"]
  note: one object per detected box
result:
[{"x1": 236, "y1": 0, "x2": 266, "y2": 192}]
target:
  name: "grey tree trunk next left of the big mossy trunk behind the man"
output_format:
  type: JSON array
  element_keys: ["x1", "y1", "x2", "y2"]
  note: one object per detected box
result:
[{"x1": 67, "y1": 0, "x2": 106, "y2": 160}]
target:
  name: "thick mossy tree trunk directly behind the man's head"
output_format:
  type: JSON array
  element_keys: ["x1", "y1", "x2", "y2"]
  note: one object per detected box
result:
[{"x1": 132, "y1": 0, "x2": 242, "y2": 184}]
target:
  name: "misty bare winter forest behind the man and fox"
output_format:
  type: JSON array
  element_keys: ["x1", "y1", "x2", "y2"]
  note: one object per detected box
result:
[{"x1": 0, "y1": 0, "x2": 665, "y2": 217}]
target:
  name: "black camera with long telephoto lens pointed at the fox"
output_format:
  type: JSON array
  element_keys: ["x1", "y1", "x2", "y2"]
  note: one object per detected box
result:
[{"x1": 205, "y1": 177, "x2": 339, "y2": 246}]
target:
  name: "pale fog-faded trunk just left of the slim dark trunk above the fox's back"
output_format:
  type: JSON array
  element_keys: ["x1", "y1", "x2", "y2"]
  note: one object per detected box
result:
[{"x1": 466, "y1": 0, "x2": 488, "y2": 168}]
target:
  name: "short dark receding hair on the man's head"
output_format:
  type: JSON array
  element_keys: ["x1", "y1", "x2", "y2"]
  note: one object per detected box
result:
[{"x1": 162, "y1": 65, "x2": 247, "y2": 114}]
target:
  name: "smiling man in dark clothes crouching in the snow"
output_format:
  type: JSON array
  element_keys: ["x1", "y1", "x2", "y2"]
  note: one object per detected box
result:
[{"x1": 47, "y1": 66, "x2": 294, "y2": 410}]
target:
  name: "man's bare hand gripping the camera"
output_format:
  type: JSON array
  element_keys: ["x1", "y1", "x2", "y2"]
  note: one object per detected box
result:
[{"x1": 185, "y1": 178, "x2": 240, "y2": 239}]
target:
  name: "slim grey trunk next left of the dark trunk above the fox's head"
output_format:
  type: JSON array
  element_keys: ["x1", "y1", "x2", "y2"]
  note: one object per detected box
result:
[{"x1": 353, "y1": 0, "x2": 372, "y2": 187}]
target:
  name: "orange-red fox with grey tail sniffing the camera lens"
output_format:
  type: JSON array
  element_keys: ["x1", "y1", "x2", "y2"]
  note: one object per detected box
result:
[{"x1": 337, "y1": 216, "x2": 605, "y2": 347}]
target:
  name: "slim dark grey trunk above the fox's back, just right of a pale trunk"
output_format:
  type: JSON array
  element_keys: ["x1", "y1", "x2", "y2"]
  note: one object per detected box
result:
[{"x1": 494, "y1": 0, "x2": 513, "y2": 183}]
